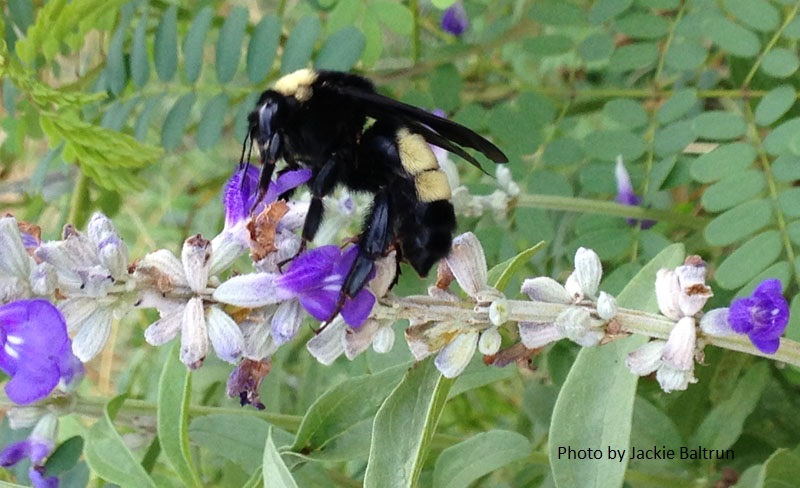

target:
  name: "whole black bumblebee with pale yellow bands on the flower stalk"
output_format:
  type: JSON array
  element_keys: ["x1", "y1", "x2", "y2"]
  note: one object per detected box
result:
[{"x1": 248, "y1": 69, "x2": 508, "y2": 319}]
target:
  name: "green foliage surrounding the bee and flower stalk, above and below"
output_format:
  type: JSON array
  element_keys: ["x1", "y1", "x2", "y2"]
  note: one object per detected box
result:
[{"x1": 0, "y1": 0, "x2": 800, "y2": 486}]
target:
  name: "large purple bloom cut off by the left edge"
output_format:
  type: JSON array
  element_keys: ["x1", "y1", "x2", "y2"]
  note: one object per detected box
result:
[{"x1": 0, "y1": 299, "x2": 83, "y2": 405}]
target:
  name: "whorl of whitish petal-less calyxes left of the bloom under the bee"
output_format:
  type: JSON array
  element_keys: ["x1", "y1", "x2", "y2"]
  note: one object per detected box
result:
[{"x1": 135, "y1": 235, "x2": 244, "y2": 369}]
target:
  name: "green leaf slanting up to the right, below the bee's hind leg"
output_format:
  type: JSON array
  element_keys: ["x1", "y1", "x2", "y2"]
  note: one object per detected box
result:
[{"x1": 292, "y1": 364, "x2": 408, "y2": 452}]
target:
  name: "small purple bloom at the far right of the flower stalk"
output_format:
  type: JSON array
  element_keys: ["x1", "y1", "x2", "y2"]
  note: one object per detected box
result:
[{"x1": 728, "y1": 278, "x2": 789, "y2": 354}]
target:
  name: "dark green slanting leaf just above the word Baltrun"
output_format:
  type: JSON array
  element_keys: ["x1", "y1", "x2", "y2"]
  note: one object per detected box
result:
[{"x1": 690, "y1": 362, "x2": 769, "y2": 449}]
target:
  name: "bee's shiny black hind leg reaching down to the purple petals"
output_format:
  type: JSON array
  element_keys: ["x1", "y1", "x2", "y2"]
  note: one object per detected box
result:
[{"x1": 326, "y1": 188, "x2": 394, "y2": 323}]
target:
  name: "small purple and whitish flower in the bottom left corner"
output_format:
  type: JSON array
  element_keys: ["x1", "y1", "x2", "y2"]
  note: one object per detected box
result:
[{"x1": 0, "y1": 413, "x2": 58, "y2": 488}]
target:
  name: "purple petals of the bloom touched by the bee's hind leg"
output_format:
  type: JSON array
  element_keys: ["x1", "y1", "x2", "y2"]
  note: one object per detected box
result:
[{"x1": 276, "y1": 246, "x2": 375, "y2": 327}]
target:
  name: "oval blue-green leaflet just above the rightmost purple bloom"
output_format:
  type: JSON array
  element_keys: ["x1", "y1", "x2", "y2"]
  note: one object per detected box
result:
[{"x1": 716, "y1": 230, "x2": 783, "y2": 290}]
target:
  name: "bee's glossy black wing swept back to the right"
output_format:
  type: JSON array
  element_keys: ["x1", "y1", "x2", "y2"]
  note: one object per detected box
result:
[{"x1": 331, "y1": 86, "x2": 508, "y2": 170}]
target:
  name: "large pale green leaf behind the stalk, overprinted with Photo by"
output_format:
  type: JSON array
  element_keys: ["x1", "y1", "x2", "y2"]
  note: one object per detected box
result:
[{"x1": 548, "y1": 244, "x2": 685, "y2": 487}]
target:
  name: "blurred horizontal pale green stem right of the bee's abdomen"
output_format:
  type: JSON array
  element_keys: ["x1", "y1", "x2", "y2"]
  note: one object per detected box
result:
[{"x1": 517, "y1": 195, "x2": 708, "y2": 229}]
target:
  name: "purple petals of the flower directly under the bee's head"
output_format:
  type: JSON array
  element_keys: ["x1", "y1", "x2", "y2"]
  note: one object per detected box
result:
[{"x1": 223, "y1": 165, "x2": 311, "y2": 229}]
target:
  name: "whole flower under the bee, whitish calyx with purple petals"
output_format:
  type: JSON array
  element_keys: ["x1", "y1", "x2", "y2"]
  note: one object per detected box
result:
[{"x1": 214, "y1": 246, "x2": 375, "y2": 327}]
